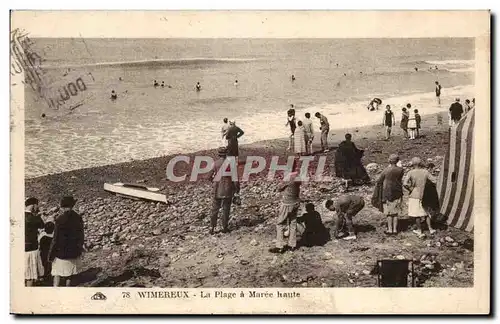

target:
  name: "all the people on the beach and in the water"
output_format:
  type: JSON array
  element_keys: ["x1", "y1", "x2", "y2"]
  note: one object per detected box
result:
[{"x1": 25, "y1": 76, "x2": 475, "y2": 286}]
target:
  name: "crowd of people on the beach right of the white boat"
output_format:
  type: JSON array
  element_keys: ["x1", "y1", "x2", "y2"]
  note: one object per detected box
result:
[{"x1": 210, "y1": 90, "x2": 475, "y2": 253}]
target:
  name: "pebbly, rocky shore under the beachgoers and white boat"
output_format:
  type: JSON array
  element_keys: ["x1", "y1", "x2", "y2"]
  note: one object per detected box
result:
[{"x1": 26, "y1": 112, "x2": 473, "y2": 287}]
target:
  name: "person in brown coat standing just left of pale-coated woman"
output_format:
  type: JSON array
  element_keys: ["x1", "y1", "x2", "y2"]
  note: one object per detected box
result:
[{"x1": 377, "y1": 154, "x2": 404, "y2": 235}]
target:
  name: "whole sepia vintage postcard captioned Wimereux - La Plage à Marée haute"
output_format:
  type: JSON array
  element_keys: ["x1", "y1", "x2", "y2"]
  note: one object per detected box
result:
[{"x1": 9, "y1": 11, "x2": 491, "y2": 314}]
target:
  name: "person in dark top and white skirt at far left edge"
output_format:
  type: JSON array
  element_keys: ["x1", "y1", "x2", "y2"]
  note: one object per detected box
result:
[{"x1": 24, "y1": 197, "x2": 44, "y2": 286}]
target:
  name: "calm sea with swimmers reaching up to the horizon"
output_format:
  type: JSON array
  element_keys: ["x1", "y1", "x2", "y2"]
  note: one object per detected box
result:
[{"x1": 24, "y1": 38, "x2": 475, "y2": 178}]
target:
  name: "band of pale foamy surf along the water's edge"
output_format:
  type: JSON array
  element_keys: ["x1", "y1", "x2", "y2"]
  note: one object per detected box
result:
[{"x1": 26, "y1": 86, "x2": 474, "y2": 177}]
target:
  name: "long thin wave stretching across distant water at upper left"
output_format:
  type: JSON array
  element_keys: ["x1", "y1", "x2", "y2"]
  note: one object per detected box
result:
[{"x1": 41, "y1": 57, "x2": 259, "y2": 70}]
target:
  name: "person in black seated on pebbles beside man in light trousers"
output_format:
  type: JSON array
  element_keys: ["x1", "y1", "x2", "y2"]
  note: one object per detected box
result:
[{"x1": 297, "y1": 203, "x2": 330, "y2": 247}]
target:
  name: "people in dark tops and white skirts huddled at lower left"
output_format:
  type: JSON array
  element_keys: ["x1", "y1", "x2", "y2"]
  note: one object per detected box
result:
[{"x1": 24, "y1": 196, "x2": 85, "y2": 287}]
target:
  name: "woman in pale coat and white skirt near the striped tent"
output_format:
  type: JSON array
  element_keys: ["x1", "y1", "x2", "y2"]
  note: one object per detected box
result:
[{"x1": 403, "y1": 157, "x2": 436, "y2": 238}]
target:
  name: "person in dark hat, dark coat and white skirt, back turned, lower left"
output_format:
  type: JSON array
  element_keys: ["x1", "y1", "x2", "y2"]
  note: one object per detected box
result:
[{"x1": 49, "y1": 196, "x2": 85, "y2": 287}]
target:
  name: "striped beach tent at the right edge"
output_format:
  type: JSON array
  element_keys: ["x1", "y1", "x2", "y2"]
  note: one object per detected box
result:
[{"x1": 437, "y1": 109, "x2": 475, "y2": 232}]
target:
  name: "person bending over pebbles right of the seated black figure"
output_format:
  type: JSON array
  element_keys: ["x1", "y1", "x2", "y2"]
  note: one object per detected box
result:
[{"x1": 325, "y1": 195, "x2": 365, "y2": 240}]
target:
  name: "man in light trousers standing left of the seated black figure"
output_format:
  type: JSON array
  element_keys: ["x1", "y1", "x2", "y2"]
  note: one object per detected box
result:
[{"x1": 269, "y1": 170, "x2": 301, "y2": 254}]
